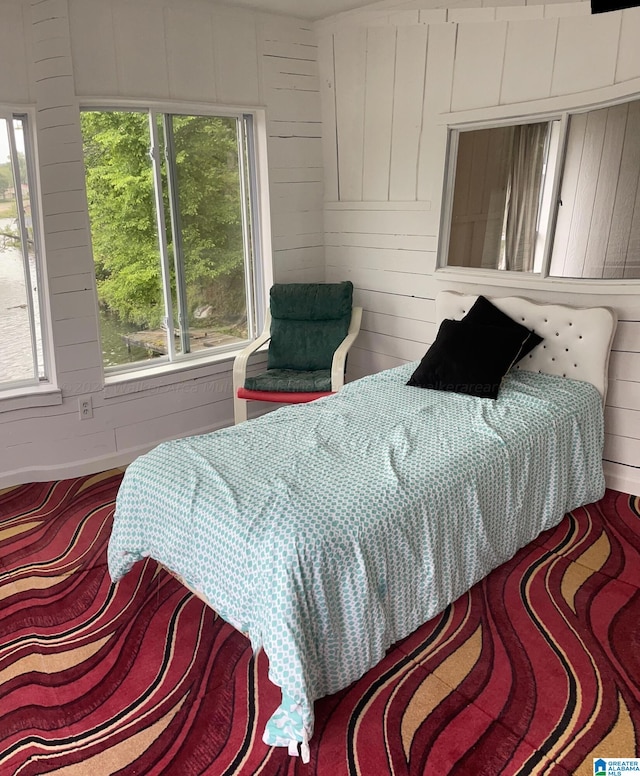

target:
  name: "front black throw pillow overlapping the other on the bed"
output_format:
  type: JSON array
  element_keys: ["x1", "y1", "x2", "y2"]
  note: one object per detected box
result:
[{"x1": 407, "y1": 319, "x2": 529, "y2": 399}]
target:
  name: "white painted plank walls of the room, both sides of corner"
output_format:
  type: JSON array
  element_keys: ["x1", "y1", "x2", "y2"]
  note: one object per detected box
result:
[{"x1": 0, "y1": 0, "x2": 640, "y2": 493}]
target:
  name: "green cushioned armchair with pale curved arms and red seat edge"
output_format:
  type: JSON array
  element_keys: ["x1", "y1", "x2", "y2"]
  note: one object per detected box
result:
[{"x1": 233, "y1": 281, "x2": 362, "y2": 423}]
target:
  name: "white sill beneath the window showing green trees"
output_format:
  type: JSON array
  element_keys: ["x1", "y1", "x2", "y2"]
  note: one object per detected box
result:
[{"x1": 102, "y1": 344, "x2": 266, "y2": 399}]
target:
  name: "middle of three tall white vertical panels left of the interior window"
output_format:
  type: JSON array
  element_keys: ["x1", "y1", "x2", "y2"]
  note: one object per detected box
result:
[{"x1": 362, "y1": 25, "x2": 398, "y2": 201}]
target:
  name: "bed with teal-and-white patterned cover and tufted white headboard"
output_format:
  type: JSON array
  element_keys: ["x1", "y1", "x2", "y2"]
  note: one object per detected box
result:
[{"x1": 108, "y1": 292, "x2": 616, "y2": 761}]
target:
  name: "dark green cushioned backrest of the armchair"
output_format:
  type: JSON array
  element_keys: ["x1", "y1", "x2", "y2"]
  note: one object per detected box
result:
[{"x1": 267, "y1": 280, "x2": 353, "y2": 371}]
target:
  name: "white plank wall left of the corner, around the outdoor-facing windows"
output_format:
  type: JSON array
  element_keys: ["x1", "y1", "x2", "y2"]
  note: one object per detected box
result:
[{"x1": 0, "y1": 0, "x2": 325, "y2": 486}]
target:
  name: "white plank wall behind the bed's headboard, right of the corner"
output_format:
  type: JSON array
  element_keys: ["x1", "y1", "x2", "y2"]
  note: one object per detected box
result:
[{"x1": 316, "y1": 0, "x2": 640, "y2": 494}]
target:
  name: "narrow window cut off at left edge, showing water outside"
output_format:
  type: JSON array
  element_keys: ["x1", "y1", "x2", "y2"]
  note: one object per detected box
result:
[{"x1": 0, "y1": 110, "x2": 46, "y2": 389}]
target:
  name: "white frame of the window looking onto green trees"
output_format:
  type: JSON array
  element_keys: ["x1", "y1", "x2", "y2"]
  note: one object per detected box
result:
[{"x1": 79, "y1": 98, "x2": 273, "y2": 380}]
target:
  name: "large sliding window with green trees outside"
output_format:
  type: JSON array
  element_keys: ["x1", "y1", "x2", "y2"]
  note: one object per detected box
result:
[{"x1": 81, "y1": 109, "x2": 261, "y2": 369}]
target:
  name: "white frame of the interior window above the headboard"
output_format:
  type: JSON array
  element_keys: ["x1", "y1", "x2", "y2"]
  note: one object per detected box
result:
[{"x1": 435, "y1": 93, "x2": 640, "y2": 294}]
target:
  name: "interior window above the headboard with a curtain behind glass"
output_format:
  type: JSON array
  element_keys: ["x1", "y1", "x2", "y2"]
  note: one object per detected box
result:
[{"x1": 440, "y1": 95, "x2": 640, "y2": 279}]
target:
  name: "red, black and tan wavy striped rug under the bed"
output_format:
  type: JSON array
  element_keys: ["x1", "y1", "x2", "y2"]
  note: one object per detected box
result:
[{"x1": 0, "y1": 472, "x2": 640, "y2": 776}]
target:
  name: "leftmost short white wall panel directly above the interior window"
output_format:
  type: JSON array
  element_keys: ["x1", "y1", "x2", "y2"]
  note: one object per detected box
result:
[{"x1": 451, "y1": 22, "x2": 507, "y2": 111}]
